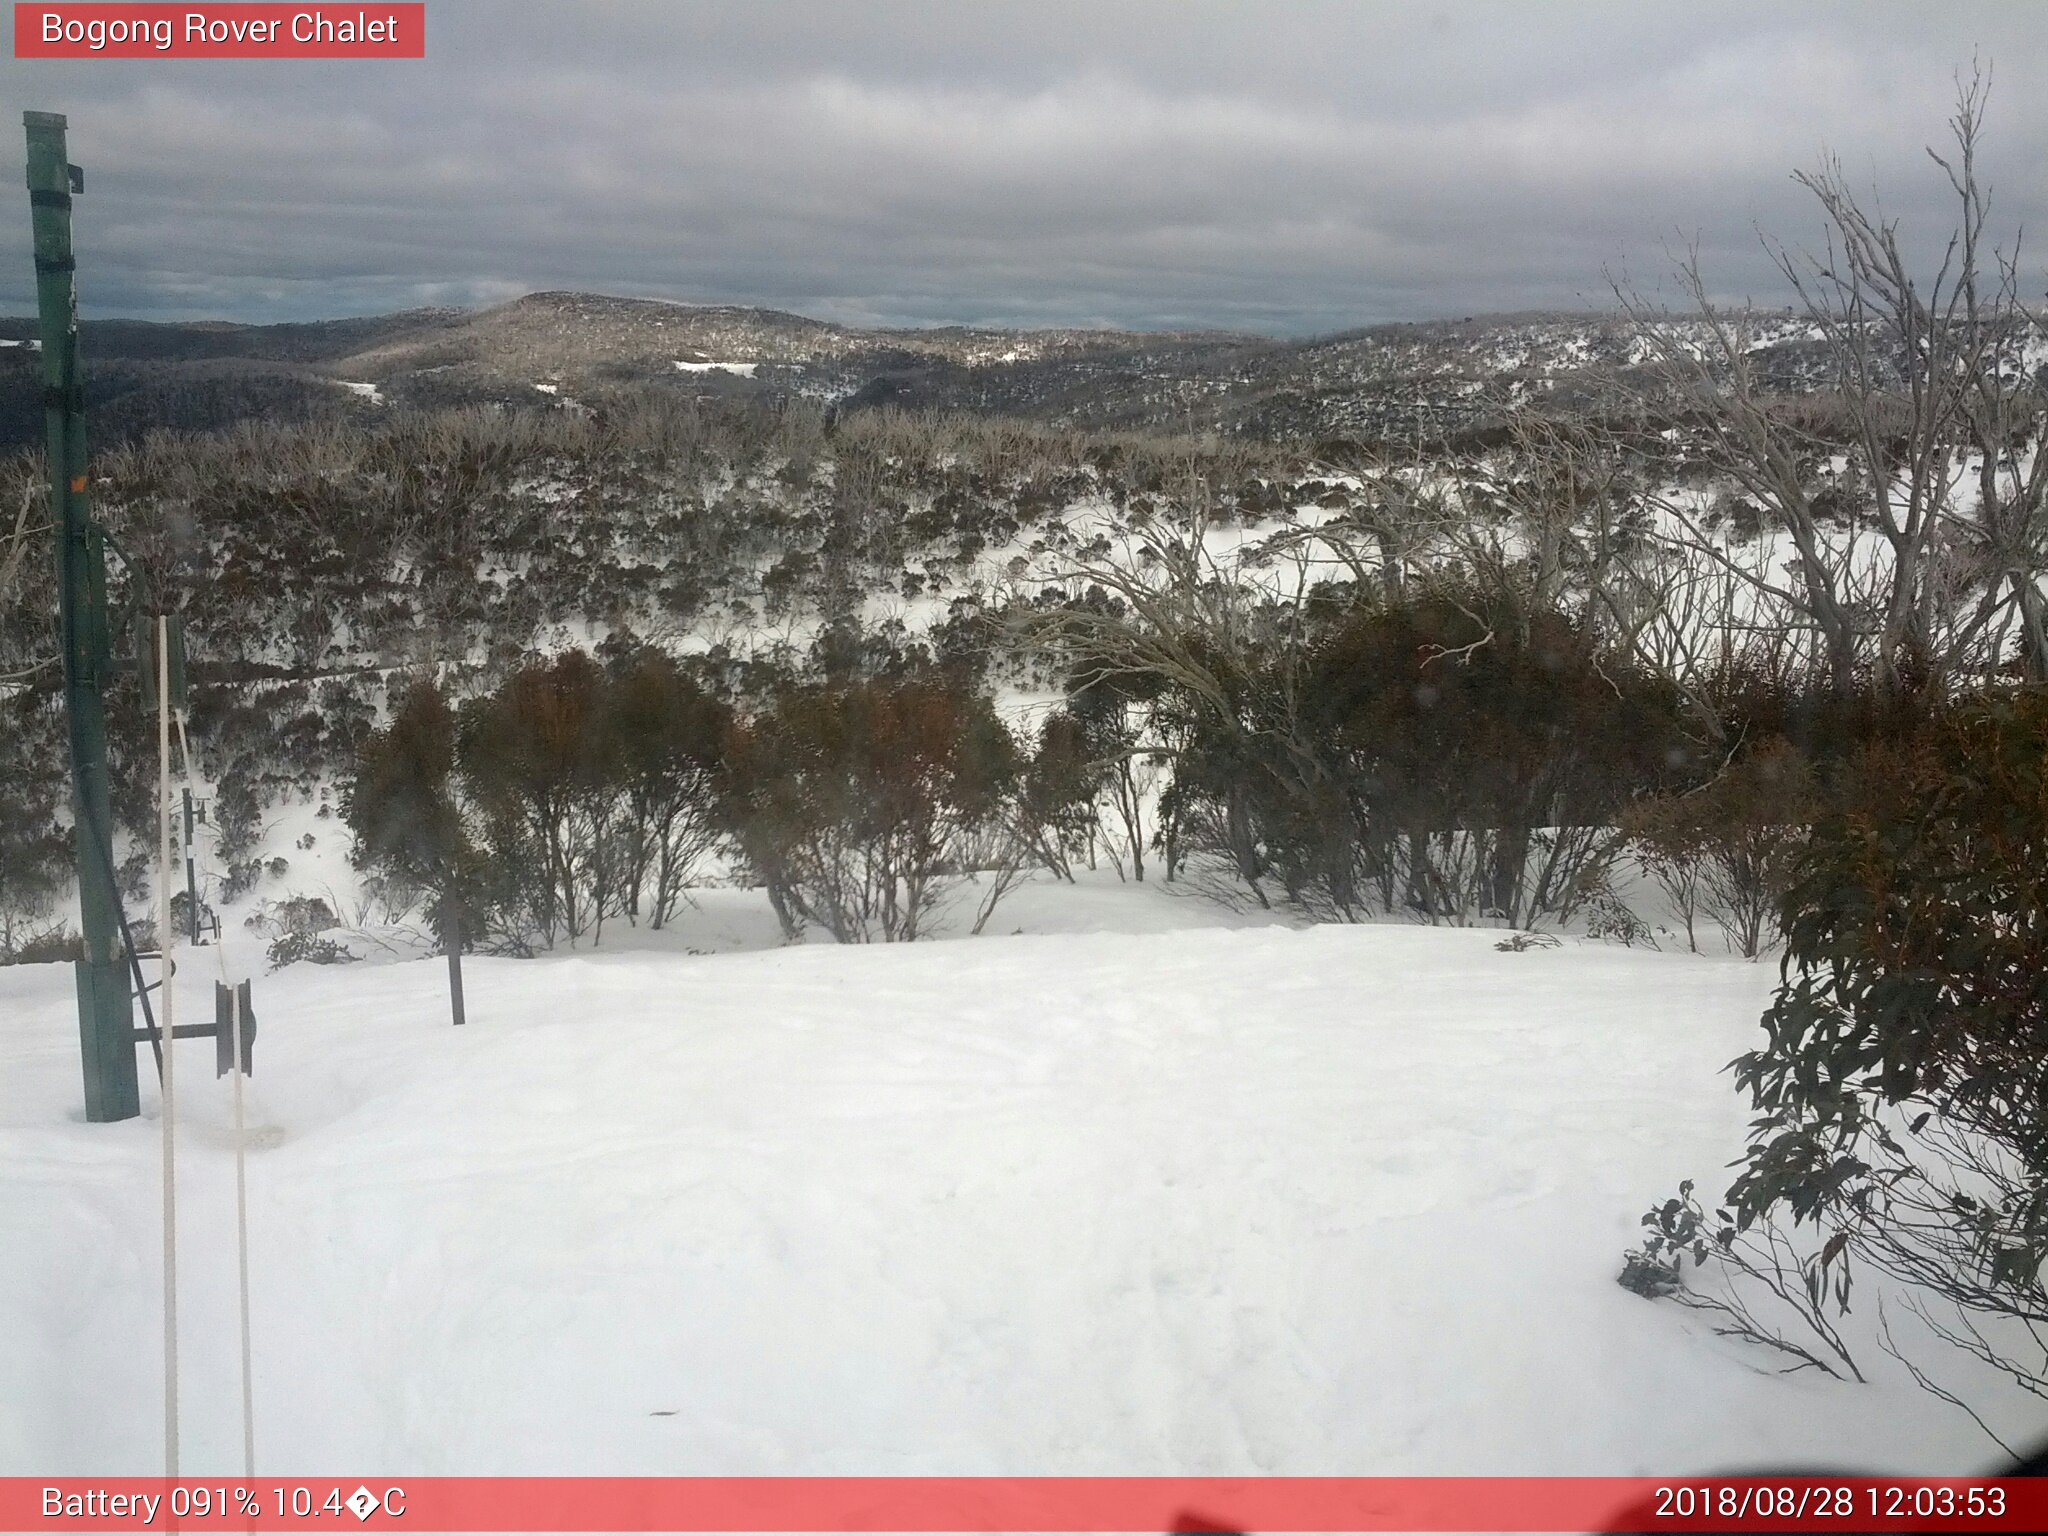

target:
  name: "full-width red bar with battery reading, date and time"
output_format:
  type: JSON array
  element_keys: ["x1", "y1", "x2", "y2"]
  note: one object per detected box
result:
[{"x1": 0, "y1": 1477, "x2": 2048, "y2": 1534}]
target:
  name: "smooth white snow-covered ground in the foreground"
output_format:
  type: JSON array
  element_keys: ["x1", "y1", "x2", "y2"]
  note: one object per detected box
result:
[{"x1": 0, "y1": 881, "x2": 2042, "y2": 1475}]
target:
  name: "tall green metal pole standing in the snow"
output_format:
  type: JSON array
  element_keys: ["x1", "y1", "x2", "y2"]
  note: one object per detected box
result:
[{"x1": 20, "y1": 113, "x2": 141, "y2": 1120}]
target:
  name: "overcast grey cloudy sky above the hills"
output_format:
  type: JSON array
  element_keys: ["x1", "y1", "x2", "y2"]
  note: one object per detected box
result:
[{"x1": 0, "y1": 0, "x2": 2048, "y2": 334}]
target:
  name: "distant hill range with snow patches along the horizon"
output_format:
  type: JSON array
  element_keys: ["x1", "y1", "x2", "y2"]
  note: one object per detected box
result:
[{"x1": 0, "y1": 293, "x2": 1802, "y2": 446}]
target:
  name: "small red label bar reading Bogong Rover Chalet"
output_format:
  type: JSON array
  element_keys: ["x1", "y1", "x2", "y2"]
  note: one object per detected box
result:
[{"x1": 14, "y1": 0, "x2": 426, "y2": 59}]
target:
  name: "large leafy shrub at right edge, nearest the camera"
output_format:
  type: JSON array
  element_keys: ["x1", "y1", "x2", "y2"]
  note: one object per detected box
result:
[{"x1": 1695, "y1": 688, "x2": 2048, "y2": 1391}]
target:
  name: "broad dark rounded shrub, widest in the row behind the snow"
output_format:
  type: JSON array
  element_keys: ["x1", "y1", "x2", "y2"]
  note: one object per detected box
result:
[{"x1": 1165, "y1": 588, "x2": 1690, "y2": 926}]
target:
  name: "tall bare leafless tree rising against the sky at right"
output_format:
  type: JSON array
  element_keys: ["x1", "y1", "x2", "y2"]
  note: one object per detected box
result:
[{"x1": 1616, "y1": 70, "x2": 2048, "y2": 684}]
